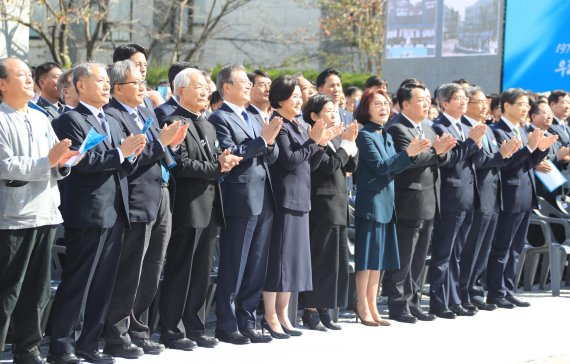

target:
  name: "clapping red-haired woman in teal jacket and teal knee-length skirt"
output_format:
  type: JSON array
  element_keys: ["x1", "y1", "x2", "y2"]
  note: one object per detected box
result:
[{"x1": 354, "y1": 88, "x2": 430, "y2": 326}]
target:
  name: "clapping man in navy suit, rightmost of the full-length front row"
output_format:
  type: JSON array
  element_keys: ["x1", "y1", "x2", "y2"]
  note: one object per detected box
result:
[{"x1": 487, "y1": 88, "x2": 557, "y2": 308}]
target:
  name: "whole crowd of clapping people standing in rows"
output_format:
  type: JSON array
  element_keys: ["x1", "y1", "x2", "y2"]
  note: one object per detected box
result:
[{"x1": 0, "y1": 44, "x2": 570, "y2": 364}]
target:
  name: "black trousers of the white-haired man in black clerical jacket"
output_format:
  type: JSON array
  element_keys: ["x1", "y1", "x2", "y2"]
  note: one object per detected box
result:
[{"x1": 159, "y1": 211, "x2": 219, "y2": 342}]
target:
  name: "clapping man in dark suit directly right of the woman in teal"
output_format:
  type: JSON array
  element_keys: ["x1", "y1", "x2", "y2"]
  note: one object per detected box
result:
[{"x1": 384, "y1": 82, "x2": 455, "y2": 323}]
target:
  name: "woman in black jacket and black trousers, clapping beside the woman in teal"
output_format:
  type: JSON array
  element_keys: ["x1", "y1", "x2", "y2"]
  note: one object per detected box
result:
[{"x1": 299, "y1": 95, "x2": 358, "y2": 331}]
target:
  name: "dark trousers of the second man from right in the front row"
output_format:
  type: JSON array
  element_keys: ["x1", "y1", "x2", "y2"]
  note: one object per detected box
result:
[{"x1": 459, "y1": 211, "x2": 499, "y2": 303}]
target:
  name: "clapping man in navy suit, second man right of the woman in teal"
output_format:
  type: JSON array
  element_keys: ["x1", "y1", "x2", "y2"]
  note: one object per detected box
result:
[{"x1": 429, "y1": 83, "x2": 487, "y2": 319}]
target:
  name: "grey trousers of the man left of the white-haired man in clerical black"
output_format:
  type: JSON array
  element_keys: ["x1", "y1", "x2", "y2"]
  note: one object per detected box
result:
[{"x1": 105, "y1": 188, "x2": 172, "y2": 344}]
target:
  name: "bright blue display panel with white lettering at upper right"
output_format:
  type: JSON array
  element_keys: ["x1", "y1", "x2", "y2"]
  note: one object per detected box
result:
[{"x1": 503, "y1": 0, "x2": 570, "y2": 92}]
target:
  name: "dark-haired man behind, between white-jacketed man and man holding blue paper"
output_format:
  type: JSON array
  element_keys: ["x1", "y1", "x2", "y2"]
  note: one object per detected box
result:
[{"x1": 34, "y1": 62, "x2": 63, "y2": 121}]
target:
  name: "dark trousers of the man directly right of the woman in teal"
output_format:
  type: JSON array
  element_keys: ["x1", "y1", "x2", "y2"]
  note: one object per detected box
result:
[{"x1": 384, "y1": 218, "x2": 433, "y2": 315}]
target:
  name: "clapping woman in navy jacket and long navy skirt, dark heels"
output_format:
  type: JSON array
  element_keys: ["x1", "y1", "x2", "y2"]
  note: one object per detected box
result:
[{"x1": 261, "y1": 76, "x2": 338, "y2": 339}]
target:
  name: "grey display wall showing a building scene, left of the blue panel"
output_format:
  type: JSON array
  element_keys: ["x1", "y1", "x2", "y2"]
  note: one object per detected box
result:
[{"x1": 382, "y1": 0, "x2": 502, "y2": 93}]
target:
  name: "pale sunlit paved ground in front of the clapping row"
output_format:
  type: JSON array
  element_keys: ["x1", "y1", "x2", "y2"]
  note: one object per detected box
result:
[{"x1": 0, "y1": 287, "x2": 570, "y2": 364}]
